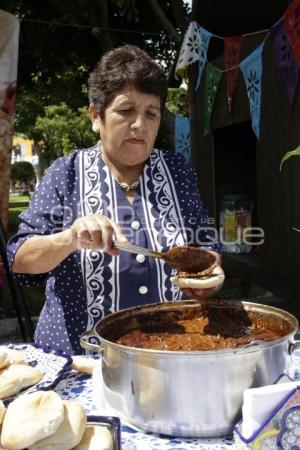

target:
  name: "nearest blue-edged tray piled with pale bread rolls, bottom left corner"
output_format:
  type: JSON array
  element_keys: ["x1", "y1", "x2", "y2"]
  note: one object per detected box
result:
[{"x1": 0, "y1": 390, "x2": 121, "y2": 450}]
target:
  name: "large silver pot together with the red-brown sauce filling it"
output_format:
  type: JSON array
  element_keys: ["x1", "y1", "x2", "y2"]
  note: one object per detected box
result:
[{"x1": 81, "y1": 299, "x2": 299, "y2": 437}]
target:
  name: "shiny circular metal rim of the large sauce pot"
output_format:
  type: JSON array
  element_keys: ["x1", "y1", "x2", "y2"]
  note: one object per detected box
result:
[{"x1": 93, "y1": 299, "x2": 299, "y2": 359}]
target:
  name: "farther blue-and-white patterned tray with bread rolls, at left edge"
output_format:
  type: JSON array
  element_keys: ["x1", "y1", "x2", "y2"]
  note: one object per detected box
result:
[{"x1": 0, "y1": 344, "x2": 72, "y2": 403}]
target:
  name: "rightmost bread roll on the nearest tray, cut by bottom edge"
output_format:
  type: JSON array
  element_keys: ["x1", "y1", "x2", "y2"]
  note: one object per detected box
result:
[{"x1": 73, "y1": 426, "x2": 114, "y2": 450}]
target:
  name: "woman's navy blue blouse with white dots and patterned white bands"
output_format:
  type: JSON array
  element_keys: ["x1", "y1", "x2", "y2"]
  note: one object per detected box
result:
[{"x1": 8, "y1": 146, "x2": 220, "y2": 354}]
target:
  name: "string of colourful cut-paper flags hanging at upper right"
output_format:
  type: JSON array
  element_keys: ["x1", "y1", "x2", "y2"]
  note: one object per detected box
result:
[{"x1": 175, "y1": 0, "x2": 300, "y2": 154}]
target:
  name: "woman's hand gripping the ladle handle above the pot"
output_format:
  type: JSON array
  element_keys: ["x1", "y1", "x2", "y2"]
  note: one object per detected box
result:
[{"x1": 70, "y1": 214, "x2": 127, "y2": 256}]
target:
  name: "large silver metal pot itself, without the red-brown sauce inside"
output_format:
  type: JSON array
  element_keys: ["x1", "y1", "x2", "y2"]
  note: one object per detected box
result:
[{"x1": 81, "y1": 299, "x2": 300, "y2": 437}]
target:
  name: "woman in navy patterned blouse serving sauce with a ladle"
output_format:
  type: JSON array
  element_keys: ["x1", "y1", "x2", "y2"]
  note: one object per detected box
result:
[{"x1": 8, "y1": 45, "x2": 222, "y2": 353}]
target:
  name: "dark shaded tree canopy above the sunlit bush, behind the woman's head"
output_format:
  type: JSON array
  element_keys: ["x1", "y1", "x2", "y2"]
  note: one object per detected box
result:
[{"x1": 1, "y1": 0, "x2": 189, "y2": 109}]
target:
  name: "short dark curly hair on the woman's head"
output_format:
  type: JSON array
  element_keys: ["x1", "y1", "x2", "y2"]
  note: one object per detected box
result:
[{"x1": 88, "y1": 45, "x2": 167, "y2": 116}]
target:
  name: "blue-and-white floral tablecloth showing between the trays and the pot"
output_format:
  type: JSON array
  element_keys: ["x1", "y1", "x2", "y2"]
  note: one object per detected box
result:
[{"x1": 51, "y1": 352, "x2": 300, "y2": 450}]
